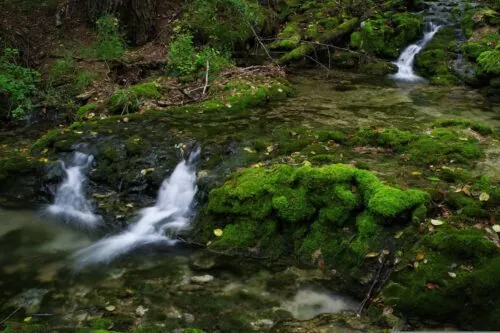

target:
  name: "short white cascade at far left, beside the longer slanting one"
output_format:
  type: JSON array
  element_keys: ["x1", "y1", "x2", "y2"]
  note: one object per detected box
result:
[{"x1": 47, "y1": 152, "x2": 101, "y2": 228}]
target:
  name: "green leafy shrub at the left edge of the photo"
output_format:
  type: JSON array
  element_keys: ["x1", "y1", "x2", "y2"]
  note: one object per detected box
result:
[{"x1": 0, "y1": 48, "x2": 40, "y2": 120}]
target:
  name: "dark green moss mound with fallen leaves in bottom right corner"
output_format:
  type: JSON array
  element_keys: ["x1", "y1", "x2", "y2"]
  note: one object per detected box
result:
[{"x1": 382, "y1": 227, "x2": 500, "y2": 329}]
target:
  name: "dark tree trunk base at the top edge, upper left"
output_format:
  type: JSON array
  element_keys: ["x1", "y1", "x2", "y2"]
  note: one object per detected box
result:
[{"x1": 71, "y1": 0, "x2": 157, "y2": 45}]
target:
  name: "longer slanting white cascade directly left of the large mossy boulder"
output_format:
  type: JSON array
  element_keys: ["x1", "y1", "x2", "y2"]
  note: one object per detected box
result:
[{"x1": 75, "y1": 149, "x2": 200, "y2": 269}]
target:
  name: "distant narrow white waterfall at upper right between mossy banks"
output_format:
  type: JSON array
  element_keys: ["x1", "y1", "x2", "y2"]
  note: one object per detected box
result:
[{"x1": 391, "y1": 22, "x2": 441, "y2": 82}]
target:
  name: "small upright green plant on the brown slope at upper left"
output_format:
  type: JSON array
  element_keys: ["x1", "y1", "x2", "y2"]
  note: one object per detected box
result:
[{"x1": 95, "y1": 15, "x2": 125, "y2": 60}]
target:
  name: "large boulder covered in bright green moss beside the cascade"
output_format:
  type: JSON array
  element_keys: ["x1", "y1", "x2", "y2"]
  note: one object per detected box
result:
[{"x1": 193, "y1": 164, "x2": 429, "y2": 275}]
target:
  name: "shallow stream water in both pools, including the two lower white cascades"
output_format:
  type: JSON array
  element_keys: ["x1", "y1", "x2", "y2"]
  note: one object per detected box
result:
[{"x1": 0, "y1": 72, "x2": 500, "y2": 332}]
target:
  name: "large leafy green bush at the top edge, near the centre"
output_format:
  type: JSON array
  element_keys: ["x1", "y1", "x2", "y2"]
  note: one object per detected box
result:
[{"x1": 187, "y1": 0, "x2": 265, "y2": 49}]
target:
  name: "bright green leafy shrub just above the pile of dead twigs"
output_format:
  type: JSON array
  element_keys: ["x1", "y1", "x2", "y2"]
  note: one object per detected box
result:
[{"x1": 168, "y1": 34, "x2": 233, "y2": 76}]
